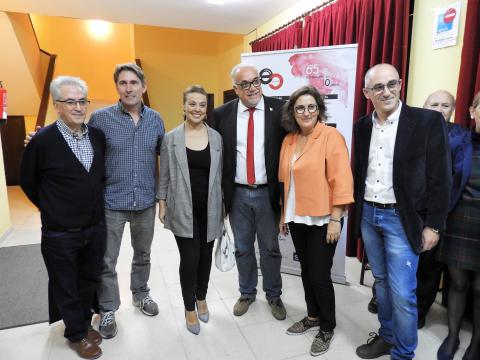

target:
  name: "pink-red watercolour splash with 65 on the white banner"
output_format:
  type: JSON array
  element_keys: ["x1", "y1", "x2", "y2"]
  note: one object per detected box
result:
[{"x1": 288, "y1": 53, "x2": 348, "y2": 107}]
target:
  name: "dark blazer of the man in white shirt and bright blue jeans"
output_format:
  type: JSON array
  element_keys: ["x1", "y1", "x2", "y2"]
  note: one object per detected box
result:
[{"x1": 354, "y1": 104, "x2": 452, "y2": 254}]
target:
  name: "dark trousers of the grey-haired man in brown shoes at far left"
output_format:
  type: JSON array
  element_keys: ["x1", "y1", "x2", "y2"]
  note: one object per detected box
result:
[{"x1": 41, "y1": 221, "x2": 106, "y2": 341}]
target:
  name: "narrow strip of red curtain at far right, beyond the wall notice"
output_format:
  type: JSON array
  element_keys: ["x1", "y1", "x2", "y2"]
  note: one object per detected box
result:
[{"x1": 455, "y1": 0, "x2": 480, "y2": 127}]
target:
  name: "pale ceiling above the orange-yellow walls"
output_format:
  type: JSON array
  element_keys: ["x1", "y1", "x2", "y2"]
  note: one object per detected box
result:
[{"x1": 0, "y1": 0, "x2": 297, "y2": 34}]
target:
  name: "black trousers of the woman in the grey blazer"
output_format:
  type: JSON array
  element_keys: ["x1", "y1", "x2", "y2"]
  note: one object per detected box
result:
[{"x1": 175, "y1": 212, "x2": 214, "y2": 311}]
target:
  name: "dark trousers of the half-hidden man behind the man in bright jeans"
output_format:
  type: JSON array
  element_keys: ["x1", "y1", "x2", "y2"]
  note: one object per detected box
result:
[{"x1": 417, "y1": 246, "x2": 444, "y2": 319}]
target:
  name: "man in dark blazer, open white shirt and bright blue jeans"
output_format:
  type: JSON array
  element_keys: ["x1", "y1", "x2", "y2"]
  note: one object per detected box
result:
[{"x1": 354, "y1": 64, "x2": 451, "y2": 360}]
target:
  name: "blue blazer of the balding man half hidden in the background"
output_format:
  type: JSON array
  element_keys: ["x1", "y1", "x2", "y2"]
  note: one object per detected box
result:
[{"x1": 447, "y1": 123, "x2": 473, "y2": 211}]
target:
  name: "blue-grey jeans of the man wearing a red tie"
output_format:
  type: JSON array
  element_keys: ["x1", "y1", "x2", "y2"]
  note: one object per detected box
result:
[{"x1": 230, "y1": 186, "x2": 282, "y2": 300}]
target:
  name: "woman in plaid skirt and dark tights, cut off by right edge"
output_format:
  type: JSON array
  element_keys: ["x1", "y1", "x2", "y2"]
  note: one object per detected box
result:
[{"x1": 437, "y1": 92, "x2": 480, "y2": 360}]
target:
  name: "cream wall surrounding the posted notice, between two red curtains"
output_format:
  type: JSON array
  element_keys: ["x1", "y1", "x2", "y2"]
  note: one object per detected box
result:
[{"x1": 407, "y1": 0, "x2": 467, "y2": 107}]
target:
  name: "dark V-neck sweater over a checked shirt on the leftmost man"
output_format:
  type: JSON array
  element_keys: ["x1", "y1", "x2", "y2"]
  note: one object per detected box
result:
[{"x1": 20, "y1": 123, "x2": 105, "y2": 231}]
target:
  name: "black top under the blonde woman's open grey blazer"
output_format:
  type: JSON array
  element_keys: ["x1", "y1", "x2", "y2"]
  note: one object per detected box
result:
[{"x1": 187, "y1": 144, "x2": 210, "y2": 213}]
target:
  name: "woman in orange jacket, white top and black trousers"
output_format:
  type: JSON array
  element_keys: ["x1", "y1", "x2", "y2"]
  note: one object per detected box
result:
[{"x1": 278, "y1": 86, "x2": 353, "y2": 356}]
